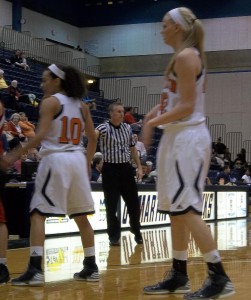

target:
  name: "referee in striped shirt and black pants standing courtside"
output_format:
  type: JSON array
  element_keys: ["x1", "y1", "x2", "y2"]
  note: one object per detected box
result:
[{"x1": 95, "y1": 102, "x2": 143, "y2": 246}]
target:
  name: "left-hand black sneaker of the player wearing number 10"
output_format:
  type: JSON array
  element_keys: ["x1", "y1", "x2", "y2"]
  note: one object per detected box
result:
[{"x1": 11, "y1": 265, "x2": 44, "y2": 286}]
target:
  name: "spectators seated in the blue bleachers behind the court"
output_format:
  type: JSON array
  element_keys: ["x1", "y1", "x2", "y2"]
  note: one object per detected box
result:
[{"x1": 0, "y1": 50, "x2": 251, "y2": 185}]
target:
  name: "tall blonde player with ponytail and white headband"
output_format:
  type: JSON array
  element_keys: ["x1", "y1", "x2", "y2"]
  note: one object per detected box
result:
[{"x1": 142, "y1": 7, "x2": 234, "y2": 300}]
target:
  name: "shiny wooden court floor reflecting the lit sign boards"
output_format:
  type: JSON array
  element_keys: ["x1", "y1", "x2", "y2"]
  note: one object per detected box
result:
[{"x1": 0, "y1": 219, "x2": 251, "y2": 300}]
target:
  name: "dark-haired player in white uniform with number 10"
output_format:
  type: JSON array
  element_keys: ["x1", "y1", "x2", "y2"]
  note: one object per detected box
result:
[{"x1": 2, "y1": 64, "x2": 99, "y2": 286}]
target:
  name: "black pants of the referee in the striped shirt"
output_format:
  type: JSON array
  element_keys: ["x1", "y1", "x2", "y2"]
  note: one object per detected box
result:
[{"x1": 102, "y1": 163, "x2": 140, "y2": 241}]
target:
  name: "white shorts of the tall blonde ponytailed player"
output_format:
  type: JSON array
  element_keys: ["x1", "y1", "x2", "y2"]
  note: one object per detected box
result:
[{"x1": 157, "y1": 123, "x2": 212, "y2": 215}]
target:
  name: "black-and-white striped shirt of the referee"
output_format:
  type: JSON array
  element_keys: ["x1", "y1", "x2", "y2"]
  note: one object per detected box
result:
[{"x1": 96, "y1": 121, "x2": 135, "y2": 164}]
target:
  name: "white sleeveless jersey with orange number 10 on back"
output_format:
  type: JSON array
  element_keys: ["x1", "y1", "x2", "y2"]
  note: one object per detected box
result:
[{"x1": 40, "y1": 93, "x2": 85, "y2": 156}]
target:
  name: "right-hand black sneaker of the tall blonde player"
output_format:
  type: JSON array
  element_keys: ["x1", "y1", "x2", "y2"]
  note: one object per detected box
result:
[{"x1": 184, "y1": 271, "x2": 235, "y2": 300}]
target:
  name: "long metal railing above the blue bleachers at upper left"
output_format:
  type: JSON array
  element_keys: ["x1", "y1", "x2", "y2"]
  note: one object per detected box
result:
[{"x1": 0, "y1": 26, "x2": 100, "y2": 77}]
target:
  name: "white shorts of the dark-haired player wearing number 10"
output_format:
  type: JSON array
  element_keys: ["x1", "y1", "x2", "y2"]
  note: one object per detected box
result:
[{"x1": 30, "y1": 151, "x2": 94, "y2": 217}]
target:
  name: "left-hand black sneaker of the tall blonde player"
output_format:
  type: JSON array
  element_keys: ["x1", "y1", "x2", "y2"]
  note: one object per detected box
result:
[{"x1": 143, "y1": 269, "x2": 190, "y2": 295}]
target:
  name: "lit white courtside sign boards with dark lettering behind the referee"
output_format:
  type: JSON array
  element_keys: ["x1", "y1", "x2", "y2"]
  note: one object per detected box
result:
[{"x1": 45, "y1": 191, "x2": 248, "y2": 235}]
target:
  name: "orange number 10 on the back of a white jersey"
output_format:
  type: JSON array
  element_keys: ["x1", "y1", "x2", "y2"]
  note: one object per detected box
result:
[{"x1": 59, "y1": 116, "x2": 82, "y2": 145}]
